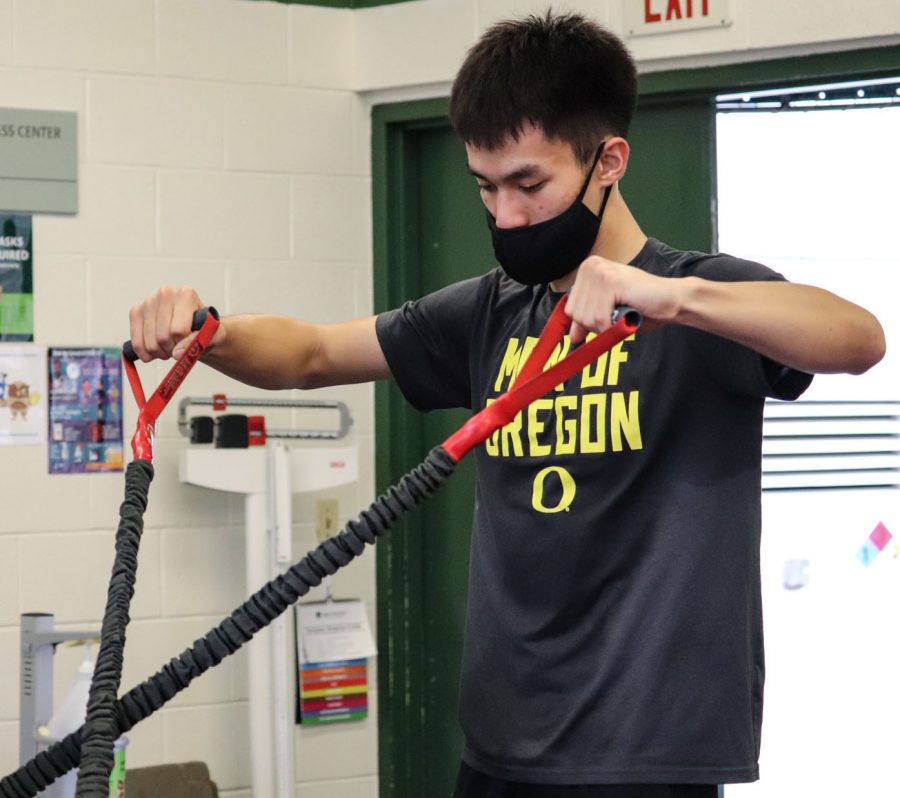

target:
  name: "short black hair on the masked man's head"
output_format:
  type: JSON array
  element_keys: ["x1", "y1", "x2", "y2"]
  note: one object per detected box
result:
[{"x1": 450, "y1": 11, "x2": 637, "y2": 163}]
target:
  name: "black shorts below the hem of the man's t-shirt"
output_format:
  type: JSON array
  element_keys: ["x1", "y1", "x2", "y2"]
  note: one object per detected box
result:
[{"x1": 453, "y1": 762, "x2": 719, "y2": 798}]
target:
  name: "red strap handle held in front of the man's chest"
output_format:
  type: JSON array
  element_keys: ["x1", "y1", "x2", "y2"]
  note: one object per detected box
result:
[{"x1": 441, "y1": 310, "x2": 641, "y2": 462}]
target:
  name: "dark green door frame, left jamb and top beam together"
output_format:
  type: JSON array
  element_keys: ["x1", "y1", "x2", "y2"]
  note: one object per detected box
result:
[{"x1": 371, "y1": 45, "x2": 900, "y2": 798}]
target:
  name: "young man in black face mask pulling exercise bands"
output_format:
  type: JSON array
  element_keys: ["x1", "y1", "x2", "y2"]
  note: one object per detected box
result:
[{"x1": 131, "y1": 14, "x2": 884, "y2": 798}]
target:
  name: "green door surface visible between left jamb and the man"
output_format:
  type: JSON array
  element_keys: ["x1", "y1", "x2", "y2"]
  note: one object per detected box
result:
[{"x1": 400, "y1": 125, "x2": 493, "y2": 796}]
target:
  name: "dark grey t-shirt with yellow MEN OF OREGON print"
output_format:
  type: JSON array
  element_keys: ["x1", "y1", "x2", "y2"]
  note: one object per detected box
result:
[{"x1": 377, "y1": 239, "x2": 811, "y2": 784}]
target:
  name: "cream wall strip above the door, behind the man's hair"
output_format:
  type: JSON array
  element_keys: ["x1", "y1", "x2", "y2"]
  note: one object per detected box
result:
[{"x1": 353, "y1": 0, "x2": 900, "y2": 94}]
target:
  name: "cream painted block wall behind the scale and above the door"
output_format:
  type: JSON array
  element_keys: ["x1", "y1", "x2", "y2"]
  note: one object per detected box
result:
[{"x1": 0, "y1": 0, "x2": 900, "y2": 798}]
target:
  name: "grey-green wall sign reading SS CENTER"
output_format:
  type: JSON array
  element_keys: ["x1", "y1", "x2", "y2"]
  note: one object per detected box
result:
[{"x1": 0, "y1": 108, "x2": 78, "y2": 213}]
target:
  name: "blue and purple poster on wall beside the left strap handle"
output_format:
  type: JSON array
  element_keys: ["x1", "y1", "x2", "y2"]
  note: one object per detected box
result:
[{"x1": 47, "y1": 347, "x2": 124, "y2": 474}]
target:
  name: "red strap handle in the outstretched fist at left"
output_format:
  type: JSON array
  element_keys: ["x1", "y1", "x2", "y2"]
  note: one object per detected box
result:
[{"x1": 122, "y1": 307, "x2": 219, "y2": 463}]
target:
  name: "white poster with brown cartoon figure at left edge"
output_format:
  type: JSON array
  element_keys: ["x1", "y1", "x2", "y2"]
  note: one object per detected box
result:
[{"x1": 0, "y1": 344, "x2": 47, "y2": 446}]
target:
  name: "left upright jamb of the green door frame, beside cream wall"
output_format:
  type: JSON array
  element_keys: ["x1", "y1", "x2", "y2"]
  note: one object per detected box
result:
[{"x1": 372, "y1": 98, "x2": 448, "y2": 798}]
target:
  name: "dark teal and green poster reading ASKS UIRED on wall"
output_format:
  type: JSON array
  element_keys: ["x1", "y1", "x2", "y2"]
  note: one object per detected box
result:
[{"x1": 0, "y1": 214, "x2": 34, "y2": 341}]
